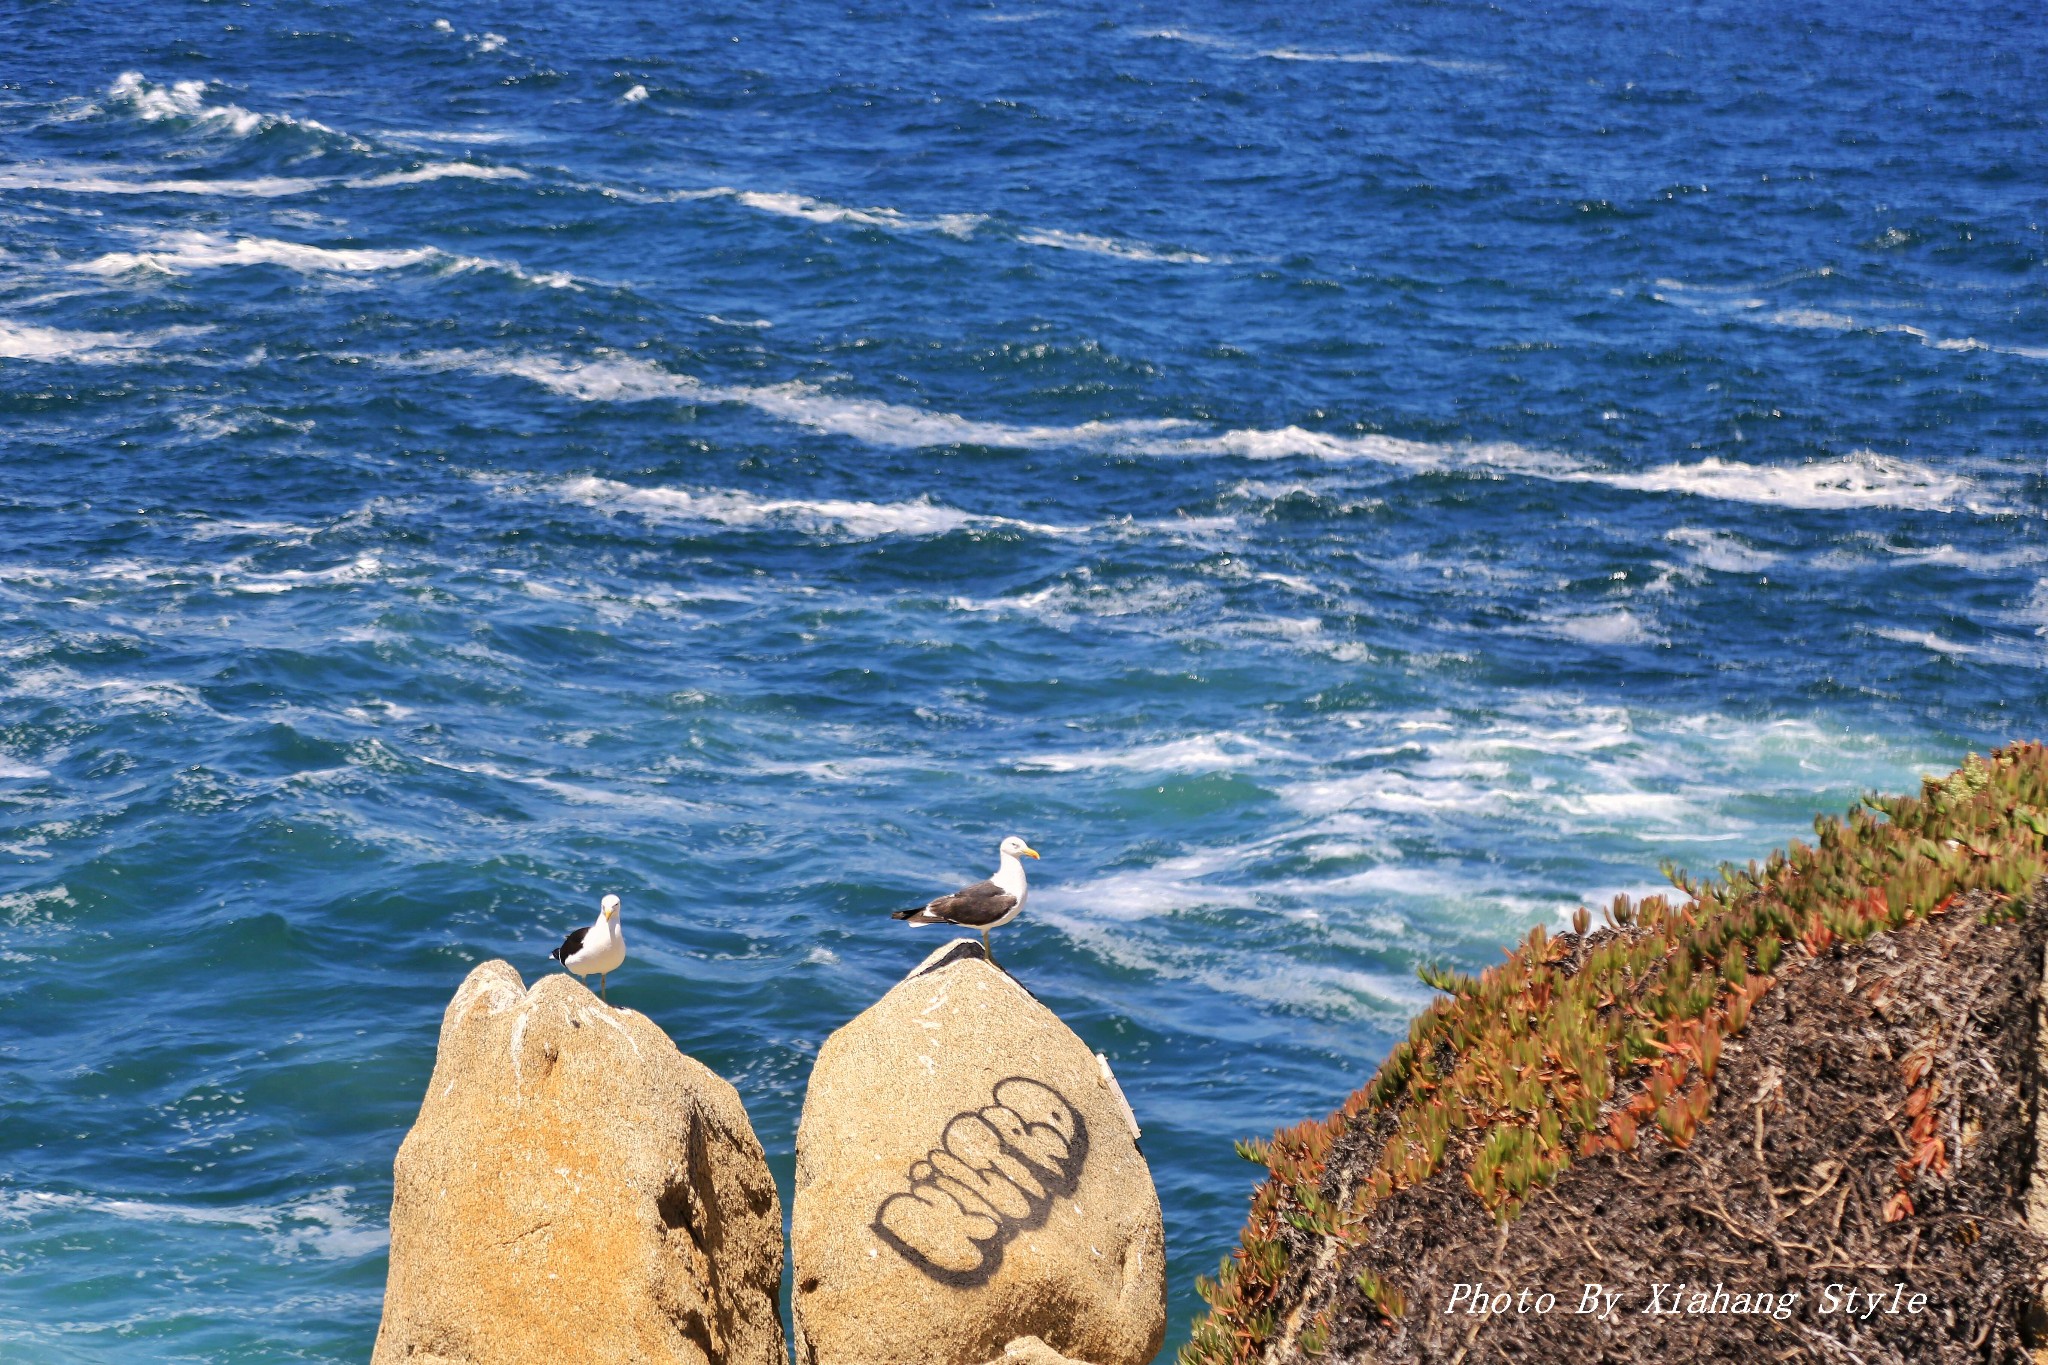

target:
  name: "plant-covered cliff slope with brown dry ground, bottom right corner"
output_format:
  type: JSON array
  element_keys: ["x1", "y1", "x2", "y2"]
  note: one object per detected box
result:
[{"x1": 1182, "y1": 745, "x2": 2048, "y2": 1365}]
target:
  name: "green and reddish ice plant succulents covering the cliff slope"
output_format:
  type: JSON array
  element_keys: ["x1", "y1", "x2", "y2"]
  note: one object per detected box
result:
[{"x1": 1180, "y1": 743, "x2": 2048, "y2": 1365}]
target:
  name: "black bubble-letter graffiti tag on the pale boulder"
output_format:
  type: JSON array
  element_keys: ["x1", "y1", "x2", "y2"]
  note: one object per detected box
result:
[{"x1": 868, "y1": 1076, "x2": 1087, "y2": 1289}]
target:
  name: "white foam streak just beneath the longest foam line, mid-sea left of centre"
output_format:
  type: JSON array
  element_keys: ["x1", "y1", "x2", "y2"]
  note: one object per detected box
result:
[{"x1": 553, "y1": 477, "x2": 1081, "y2": 538}]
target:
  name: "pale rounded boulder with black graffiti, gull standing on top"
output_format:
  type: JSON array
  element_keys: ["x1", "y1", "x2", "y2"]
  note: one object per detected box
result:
[{"x1": 791, "y1": 939, "x2": 1165, "y2": 1365}]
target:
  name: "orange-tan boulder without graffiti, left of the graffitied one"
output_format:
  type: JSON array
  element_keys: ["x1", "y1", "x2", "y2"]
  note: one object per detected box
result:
[{"x1": 373, "y1": 962, "x2": 784, "y2": 1365}]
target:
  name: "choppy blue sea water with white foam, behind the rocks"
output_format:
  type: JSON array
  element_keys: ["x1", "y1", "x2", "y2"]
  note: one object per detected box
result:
[{"x1": 0, "y1": 0, "x2": 2048, "y2": 1361}]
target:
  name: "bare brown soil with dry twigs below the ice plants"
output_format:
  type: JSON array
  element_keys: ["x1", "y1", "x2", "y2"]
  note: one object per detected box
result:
[{"x1": 1262, "y1": 884, "x2": 2048, "y2": 1365}]
